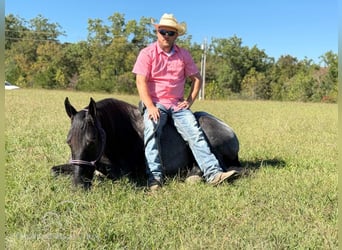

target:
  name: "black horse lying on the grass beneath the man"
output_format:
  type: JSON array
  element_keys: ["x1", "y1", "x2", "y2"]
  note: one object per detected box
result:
[{"x1": 51, "y1": 98, "x2": 240, "y2": 189}]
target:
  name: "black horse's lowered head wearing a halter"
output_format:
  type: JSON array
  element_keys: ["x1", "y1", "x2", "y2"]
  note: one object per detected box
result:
[{"x1": 64, "y1": 98, "x2": 106, "y2": 189}]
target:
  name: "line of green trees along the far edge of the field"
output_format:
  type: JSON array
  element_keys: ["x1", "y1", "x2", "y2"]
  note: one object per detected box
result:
[{"x1": 5, "y1": 13, "x2": 338, "y2": 102}]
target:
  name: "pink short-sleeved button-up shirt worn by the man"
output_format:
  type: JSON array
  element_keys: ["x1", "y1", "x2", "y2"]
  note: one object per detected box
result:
[{"x1": 133, "y1": 42, "x2": 198, "y2": 109}]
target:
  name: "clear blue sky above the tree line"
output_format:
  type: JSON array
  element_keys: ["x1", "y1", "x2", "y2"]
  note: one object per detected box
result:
[{"x1": 5, "y1": 0, "x2": 338, "y2": 63}]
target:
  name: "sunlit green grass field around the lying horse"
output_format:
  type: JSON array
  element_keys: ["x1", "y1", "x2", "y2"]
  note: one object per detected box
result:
[{"x1": 5, "y1": 89, "x2": 338, "y2": 249}]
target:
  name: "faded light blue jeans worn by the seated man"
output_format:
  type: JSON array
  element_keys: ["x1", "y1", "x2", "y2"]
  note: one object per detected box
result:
[{"x1": 144, "y1": 104, "x2": 223, "y2": 182}]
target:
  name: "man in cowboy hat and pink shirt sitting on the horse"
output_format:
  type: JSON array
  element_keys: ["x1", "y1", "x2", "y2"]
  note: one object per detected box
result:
[{"x1": 133, "y1": 14, "x2": 238, "y2": 191}]
